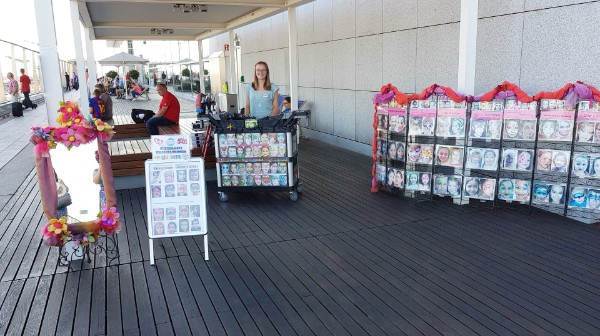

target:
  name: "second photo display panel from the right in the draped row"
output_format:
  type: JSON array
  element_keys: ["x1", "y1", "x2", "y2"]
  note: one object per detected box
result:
[{"x1": 532, "y1": 99, "x2": 575, "y2": 215}]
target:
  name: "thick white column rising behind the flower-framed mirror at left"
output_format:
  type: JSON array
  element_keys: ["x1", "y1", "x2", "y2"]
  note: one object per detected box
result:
[{"x1": 33, "y1": 0, "x2": 65, "y2": 126}]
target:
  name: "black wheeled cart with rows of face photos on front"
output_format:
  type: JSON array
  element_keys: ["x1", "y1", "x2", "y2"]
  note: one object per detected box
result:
[{"x1": 210, "y1": 111, "x2": 306, "y2": 202}]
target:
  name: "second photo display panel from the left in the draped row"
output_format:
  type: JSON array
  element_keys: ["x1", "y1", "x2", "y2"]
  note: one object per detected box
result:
[{"x1": 404, "y1": 95, "x2": 437, "y2": 201}]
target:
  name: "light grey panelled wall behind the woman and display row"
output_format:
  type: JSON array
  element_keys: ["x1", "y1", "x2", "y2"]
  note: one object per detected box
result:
[{"x1": 205, "y1": 0, "x2": 600, "y2": 148}]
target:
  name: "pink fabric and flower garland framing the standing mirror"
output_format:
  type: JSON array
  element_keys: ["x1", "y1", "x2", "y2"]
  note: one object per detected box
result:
[{"x1": 30, "y1": 101, "x2": 121, "y2": 247}]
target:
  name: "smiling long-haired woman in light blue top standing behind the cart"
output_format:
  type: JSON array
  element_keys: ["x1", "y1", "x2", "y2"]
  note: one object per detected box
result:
[{"x1": 245, "y1": 62, "x2": 279, "y2": 118}]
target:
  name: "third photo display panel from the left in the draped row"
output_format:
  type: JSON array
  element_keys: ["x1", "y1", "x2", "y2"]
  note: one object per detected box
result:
[{"x1": 432, "y1": 95, "x2": 467, "y2": 201}]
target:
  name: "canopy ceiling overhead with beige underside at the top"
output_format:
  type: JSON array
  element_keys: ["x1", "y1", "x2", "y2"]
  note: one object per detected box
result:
[{"x1": 77, "y1": 0, "x2": 313, "y2": 41}]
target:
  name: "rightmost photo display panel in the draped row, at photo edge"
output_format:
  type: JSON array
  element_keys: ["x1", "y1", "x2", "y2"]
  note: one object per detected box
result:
[{"x1": 566, "y1": 101, "x2": 600, "y2": 224}]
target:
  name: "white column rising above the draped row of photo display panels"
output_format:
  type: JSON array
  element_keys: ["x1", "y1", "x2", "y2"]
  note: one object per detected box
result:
[{"x1": 458, "y1": 0, "x2": 479, "y2": 95}]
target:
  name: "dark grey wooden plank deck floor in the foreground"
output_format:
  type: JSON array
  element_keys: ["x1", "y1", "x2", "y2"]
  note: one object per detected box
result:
[{"x1": 0, "y1": 140, "x2": 600, "y2": 336}]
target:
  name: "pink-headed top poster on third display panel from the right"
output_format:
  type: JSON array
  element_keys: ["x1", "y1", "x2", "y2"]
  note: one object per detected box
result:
[{"x1": 502, "y1": 100, "x2": 537, "y2": 141}]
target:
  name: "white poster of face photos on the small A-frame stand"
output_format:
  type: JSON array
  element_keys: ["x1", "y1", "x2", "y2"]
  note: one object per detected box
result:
[{"x1": 145, "y1": 158, "x2": 207, "y2": 238}]
